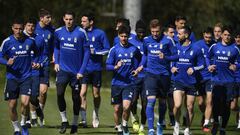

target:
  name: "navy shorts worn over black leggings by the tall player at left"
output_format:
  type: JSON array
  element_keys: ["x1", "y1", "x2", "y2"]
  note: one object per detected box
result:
[{"x1": 56, "y1": 69, "x2": 81, "y2": 91}]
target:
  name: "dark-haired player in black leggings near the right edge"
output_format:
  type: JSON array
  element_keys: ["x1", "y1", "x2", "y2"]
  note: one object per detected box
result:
[{"x1": 207, "y1": 27, "x2": 239, "y2": 135}]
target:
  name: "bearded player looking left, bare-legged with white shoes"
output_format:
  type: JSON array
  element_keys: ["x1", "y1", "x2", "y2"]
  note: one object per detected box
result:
[{"x1": 171, "y1": 26, "x2": 204, "y2": 135}]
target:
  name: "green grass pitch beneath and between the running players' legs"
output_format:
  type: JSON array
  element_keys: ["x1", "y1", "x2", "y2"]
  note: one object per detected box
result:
[{"x1": 0, "y1": 74, "x2": 240, "y2": 135}]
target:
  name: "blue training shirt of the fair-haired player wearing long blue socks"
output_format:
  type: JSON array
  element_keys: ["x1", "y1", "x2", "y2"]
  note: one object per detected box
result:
[{"x1": 143, "y1": 36, "x2": 177, "y2": 75}]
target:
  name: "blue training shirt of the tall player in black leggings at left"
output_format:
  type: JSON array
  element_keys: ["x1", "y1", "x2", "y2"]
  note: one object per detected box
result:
[{"x1": 54, "y1": 26, "x2": 90, "y2": 74}]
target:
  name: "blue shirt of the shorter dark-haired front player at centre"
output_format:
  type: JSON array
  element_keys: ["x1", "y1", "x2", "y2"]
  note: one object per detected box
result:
[{"x1": 106, "y1": 43, "x2": 141, "y2": 86}]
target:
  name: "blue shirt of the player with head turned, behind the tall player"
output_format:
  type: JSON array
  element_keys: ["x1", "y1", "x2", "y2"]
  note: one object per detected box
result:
[{"x1": 86, "y1": 27, "x2": 110, "y2": 72}]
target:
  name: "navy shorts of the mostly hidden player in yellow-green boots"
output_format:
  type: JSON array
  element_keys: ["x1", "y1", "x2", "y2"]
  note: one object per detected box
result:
[{"x1": 133, "y1": 77, "x2": 146, "y2": 99}]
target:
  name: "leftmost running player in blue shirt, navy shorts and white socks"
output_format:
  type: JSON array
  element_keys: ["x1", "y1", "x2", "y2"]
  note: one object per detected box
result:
[{"x1": 0, "y1": 19, "x2": 38, "y2": 135}]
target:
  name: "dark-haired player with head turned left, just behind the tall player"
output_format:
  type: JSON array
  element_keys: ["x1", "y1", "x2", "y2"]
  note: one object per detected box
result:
[{"x1": 80, "y1": 12, "x2": 110, "y2": 128}]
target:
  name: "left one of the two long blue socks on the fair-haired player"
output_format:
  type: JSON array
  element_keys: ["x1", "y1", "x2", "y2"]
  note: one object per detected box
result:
[{"x1": 146, "y1": 99, "x2": 156, "y2": 130}]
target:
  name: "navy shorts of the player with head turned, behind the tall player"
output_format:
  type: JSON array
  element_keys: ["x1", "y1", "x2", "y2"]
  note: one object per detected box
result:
[{"x1": 82, "y1": 71, "x2": 102, "y2": 88}]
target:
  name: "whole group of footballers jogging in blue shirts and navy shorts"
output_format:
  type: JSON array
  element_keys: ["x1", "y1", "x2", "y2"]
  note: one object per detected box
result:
[{"x1": 0, "y1": 9, "x2": 240, "y2": 135}]
